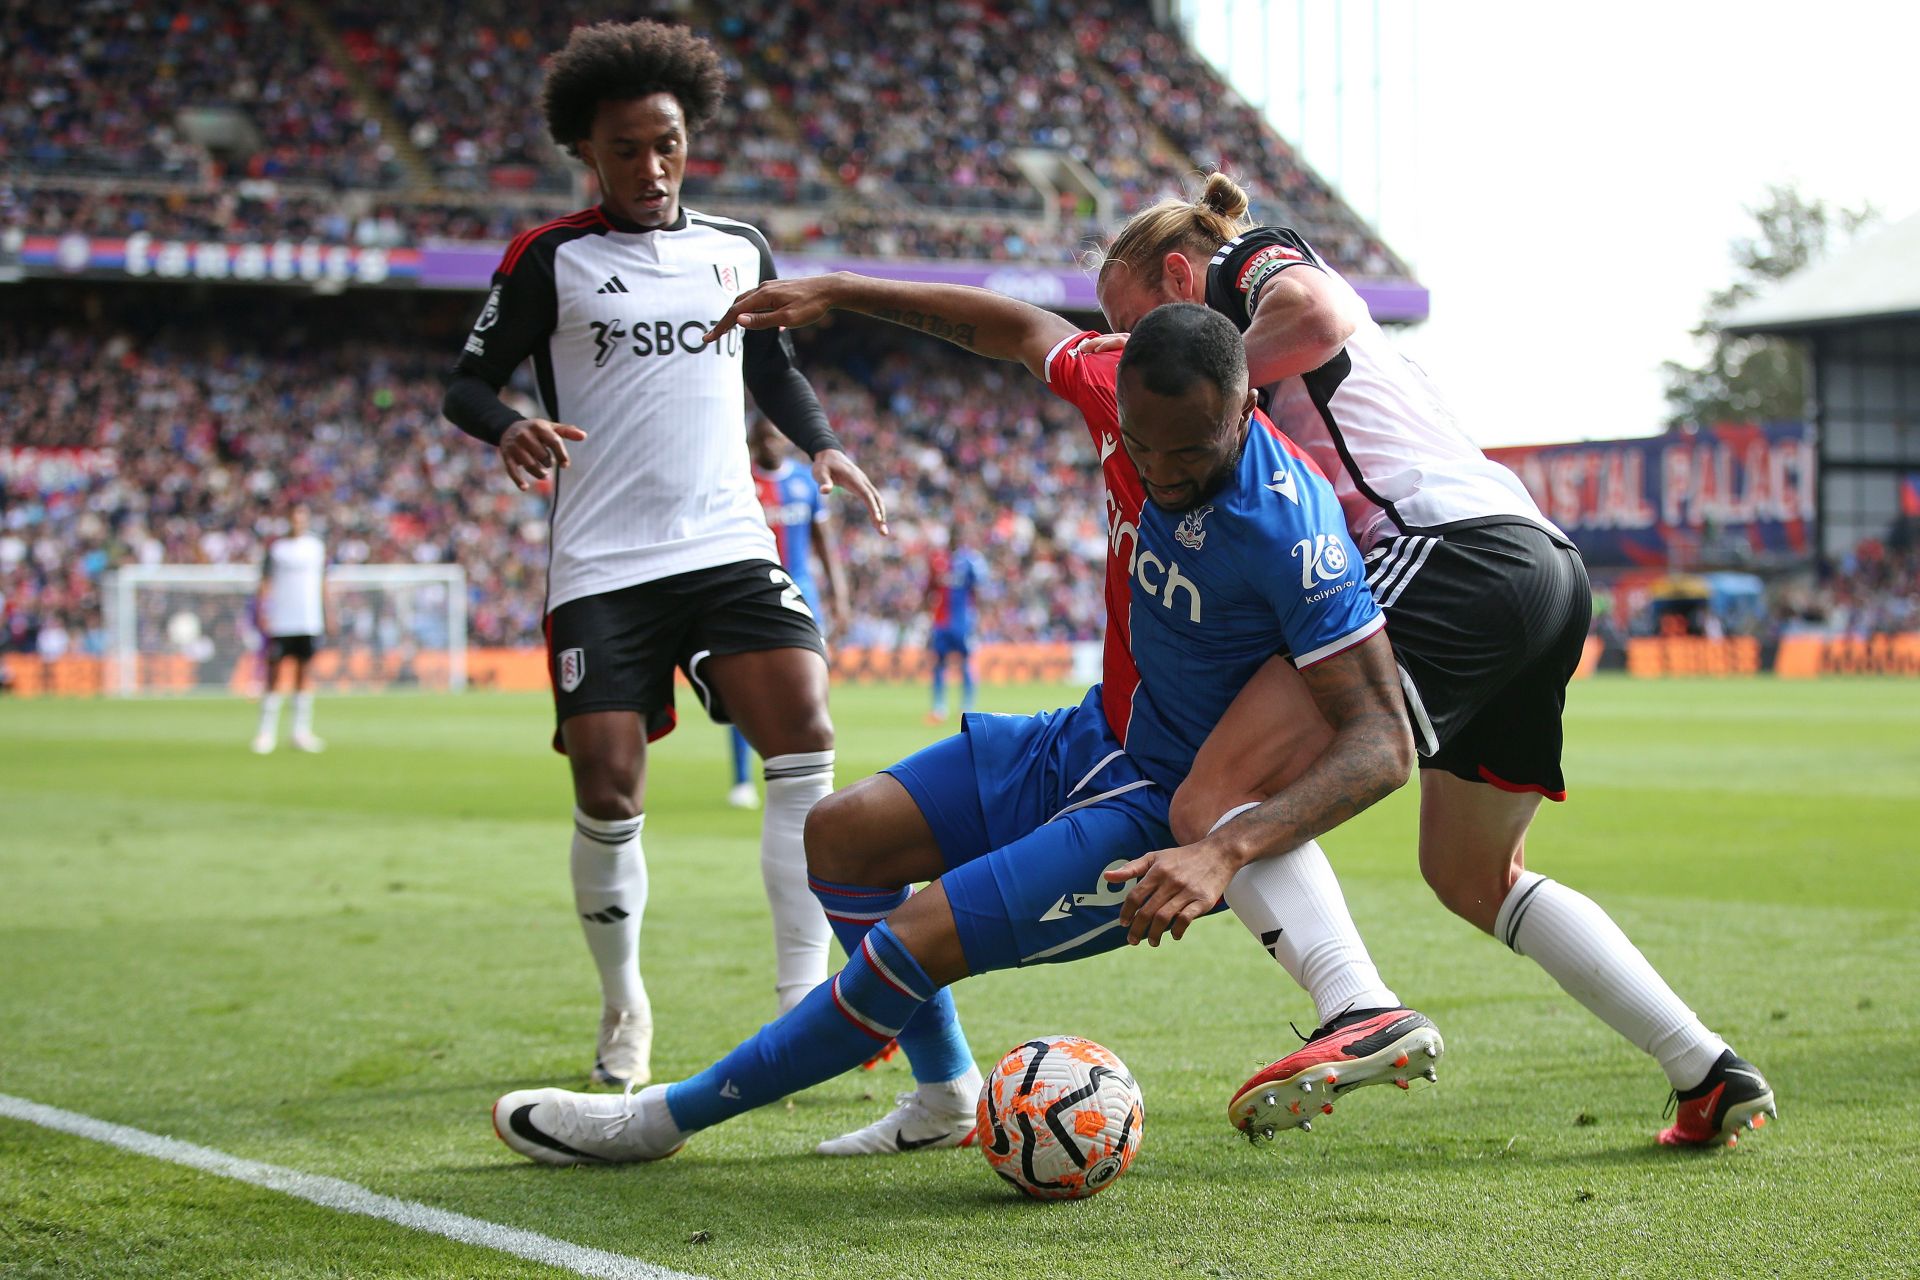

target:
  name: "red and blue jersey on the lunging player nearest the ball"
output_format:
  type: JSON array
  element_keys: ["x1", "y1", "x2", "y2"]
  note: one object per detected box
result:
[{"x1": 1046, "y1": 338, "x2": 1386, "y2": 791}]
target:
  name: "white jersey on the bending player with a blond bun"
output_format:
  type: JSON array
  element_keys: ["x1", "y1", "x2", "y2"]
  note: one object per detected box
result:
[{"x1": 1206, "y1": 226, "x2": 1572, "y2": 551}]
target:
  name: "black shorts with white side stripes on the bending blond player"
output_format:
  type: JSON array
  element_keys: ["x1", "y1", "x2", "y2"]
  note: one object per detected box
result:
[{"x1": 1367, "y1": 522, "x2": 1594, "y2": 800}]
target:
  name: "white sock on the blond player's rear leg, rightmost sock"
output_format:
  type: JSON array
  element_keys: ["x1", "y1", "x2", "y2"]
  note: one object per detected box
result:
[{"x1": 1494, "y1": 871, "x2": 1726, "y2": 1088}]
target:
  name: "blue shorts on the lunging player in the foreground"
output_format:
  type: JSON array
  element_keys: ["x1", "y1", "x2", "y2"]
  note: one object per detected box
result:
[{"x1": 885, "y1": 685, "x2": 1175, "y2": 973}]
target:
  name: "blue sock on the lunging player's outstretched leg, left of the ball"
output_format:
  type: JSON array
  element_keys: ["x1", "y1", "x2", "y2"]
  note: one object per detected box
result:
[{"x1": 666, "y1": 921, "x2": 933, "y2": 1132}]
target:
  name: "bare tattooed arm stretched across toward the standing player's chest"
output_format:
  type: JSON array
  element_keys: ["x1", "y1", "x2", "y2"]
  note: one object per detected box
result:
[{"x1": 707, "y1": 271, "x2": 1081, "y2": 378}]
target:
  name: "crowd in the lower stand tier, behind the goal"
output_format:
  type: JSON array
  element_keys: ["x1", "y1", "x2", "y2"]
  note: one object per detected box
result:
[{"x1": 0, "y1": 299, "x2": 1104, "y2": 656}]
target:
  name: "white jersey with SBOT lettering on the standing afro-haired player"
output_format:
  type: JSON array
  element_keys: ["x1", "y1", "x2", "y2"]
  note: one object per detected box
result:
[{"x1": 461, "y1": 209, "x2": 793, "y2": 612}]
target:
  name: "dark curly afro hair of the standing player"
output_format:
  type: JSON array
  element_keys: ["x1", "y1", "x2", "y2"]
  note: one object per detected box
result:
[{"x1": 540, "y1": 21, "x2": 726, "y2": 155}]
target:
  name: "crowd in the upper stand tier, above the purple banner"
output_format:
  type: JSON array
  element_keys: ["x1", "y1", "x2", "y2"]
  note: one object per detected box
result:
[{"x1": 0, "y1": 0, "x2": 1402, "y2": 274}]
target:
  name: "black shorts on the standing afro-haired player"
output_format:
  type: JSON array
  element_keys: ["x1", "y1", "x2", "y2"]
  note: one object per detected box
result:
[{"x1": 547, "y1": 560, "x2": 828, "y2": 750}]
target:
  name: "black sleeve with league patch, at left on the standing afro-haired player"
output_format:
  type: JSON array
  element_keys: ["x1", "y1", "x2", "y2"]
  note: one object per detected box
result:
[{"x1": 442, "y1": 238, "x2": 559, "y2": 445}]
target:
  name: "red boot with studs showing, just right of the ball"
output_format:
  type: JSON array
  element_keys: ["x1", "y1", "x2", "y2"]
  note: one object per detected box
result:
[{"x1": 1227, "y1": 1009, "x2": 1446, "y2": 1142}]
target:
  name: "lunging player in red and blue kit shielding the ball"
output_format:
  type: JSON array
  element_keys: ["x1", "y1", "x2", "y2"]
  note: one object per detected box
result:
[{"x1": 493, "y1": 305, "x2": 1440, "y2": 1165}]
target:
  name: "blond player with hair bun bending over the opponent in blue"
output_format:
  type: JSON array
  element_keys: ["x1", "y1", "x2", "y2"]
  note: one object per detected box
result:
[{"x1": 1098, "y1": 173, "x2": 1774, "y2": 1146}]
